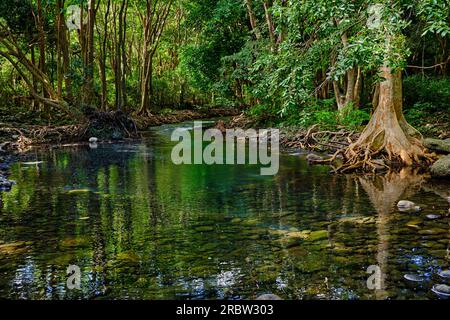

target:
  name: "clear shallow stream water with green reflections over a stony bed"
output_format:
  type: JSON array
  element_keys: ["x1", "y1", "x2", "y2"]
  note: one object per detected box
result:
[{"x1": 0, "y1": 123, "x2": 450, "y2": 299}]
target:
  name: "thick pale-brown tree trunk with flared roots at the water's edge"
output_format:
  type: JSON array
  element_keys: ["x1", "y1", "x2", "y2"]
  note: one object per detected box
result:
[{"x1": 339, "y1": 66, "x2": 430, "y2": 171}]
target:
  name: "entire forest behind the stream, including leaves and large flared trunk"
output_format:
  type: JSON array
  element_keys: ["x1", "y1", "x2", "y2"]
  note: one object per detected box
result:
[{"x1": 0, "y1": 0, "x2": 450, "y2": 170}]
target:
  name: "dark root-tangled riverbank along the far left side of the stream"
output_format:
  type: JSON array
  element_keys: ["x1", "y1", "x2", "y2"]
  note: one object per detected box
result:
[{"x1": 0, "y1": 108, "x2": 240, "y2": 151}]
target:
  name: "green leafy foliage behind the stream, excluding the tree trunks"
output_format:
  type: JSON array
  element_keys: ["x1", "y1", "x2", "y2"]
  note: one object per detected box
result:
[{"x1": 0, "y1": 0, "x2": 450, "y2": 128}]
